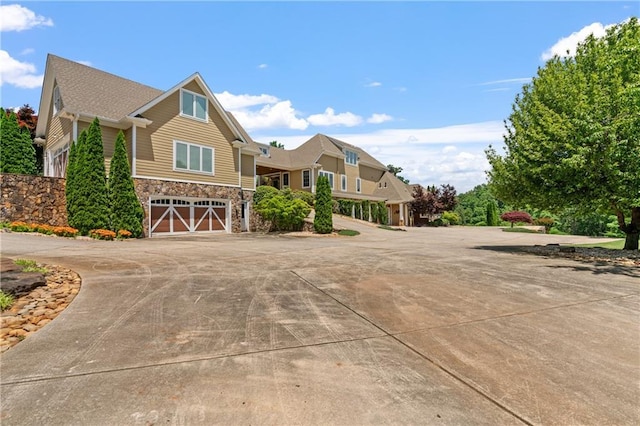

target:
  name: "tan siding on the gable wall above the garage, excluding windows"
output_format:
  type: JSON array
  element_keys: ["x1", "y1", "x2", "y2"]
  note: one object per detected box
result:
[{"x1": 136, "y1": 82, "x2": 239, "y2": 186}]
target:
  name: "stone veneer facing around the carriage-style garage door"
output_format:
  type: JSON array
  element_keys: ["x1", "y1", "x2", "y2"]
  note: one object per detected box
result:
[{"x1": 133, "y1": 178, "x2": 260, "y2": 237}]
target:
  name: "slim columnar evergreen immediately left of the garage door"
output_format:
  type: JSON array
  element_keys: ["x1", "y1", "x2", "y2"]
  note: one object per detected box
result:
[{"x1": 108, "y1": 131, "x2": 144, "y2": 237}]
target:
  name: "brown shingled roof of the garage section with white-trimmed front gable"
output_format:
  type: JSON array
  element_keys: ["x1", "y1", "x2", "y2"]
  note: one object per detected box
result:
[{"x1": 36, "y1": 54, "x2": 248, "y2": 144}]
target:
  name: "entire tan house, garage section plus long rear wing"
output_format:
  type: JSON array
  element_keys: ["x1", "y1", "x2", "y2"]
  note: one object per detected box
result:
[{"x1": 36, "y1": 55, "x2": 420, "y2": 236}]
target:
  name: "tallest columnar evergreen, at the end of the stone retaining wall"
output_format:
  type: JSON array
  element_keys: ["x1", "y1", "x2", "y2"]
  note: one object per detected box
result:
[{"x1": 69, "y1": 118, "x2": 110, "y2": 235}]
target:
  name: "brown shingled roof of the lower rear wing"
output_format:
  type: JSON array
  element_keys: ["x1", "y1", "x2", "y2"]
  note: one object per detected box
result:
[{"x1": 257, "y1": 133, "x2": 387, "y2": 170}]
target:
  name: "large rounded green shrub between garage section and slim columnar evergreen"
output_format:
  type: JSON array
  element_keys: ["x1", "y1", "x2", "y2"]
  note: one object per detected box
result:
[{"x1": 256, "y1": 194, "x2": 311, "y2": 231}]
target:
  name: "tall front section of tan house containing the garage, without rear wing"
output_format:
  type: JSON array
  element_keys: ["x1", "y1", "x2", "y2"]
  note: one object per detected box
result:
[{"x1": 36, "y1": 55, "x2": 260, "y2": 236}]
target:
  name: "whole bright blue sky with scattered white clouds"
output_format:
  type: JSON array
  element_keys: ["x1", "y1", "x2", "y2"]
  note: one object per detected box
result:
[{"x1": 0, "y1": 1, "x2": 640, "y2": 192}]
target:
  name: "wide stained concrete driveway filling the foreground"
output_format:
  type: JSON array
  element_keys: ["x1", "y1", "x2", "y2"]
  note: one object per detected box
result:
[{"x1": 0, "y1": 223, "x2": 640, "y2": 425}]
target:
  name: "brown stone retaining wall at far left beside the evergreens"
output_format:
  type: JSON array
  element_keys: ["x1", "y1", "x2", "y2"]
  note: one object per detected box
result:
[{"x1": 0, "y1": 173, "x2": 67, "y2": 226}]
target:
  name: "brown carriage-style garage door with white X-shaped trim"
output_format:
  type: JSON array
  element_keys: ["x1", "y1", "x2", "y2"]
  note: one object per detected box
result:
[{"x1": 149, "y1": 197, "x2": 229, "y2": 236}]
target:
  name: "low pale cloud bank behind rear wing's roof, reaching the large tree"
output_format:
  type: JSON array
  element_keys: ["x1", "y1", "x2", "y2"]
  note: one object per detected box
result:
[{"x1": 253, "y1": 121, "x2": 504, "y2": 193}]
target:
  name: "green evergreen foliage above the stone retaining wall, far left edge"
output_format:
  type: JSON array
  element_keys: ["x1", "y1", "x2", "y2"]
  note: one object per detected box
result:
[{"x1": 0, "y1": 108, "x2": 37, "y2": 175}]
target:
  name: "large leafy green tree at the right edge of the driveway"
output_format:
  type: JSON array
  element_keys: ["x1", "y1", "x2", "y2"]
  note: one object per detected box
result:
[{"x1": 487, "y1": 18, "x2": 640, "y2": 250}]
